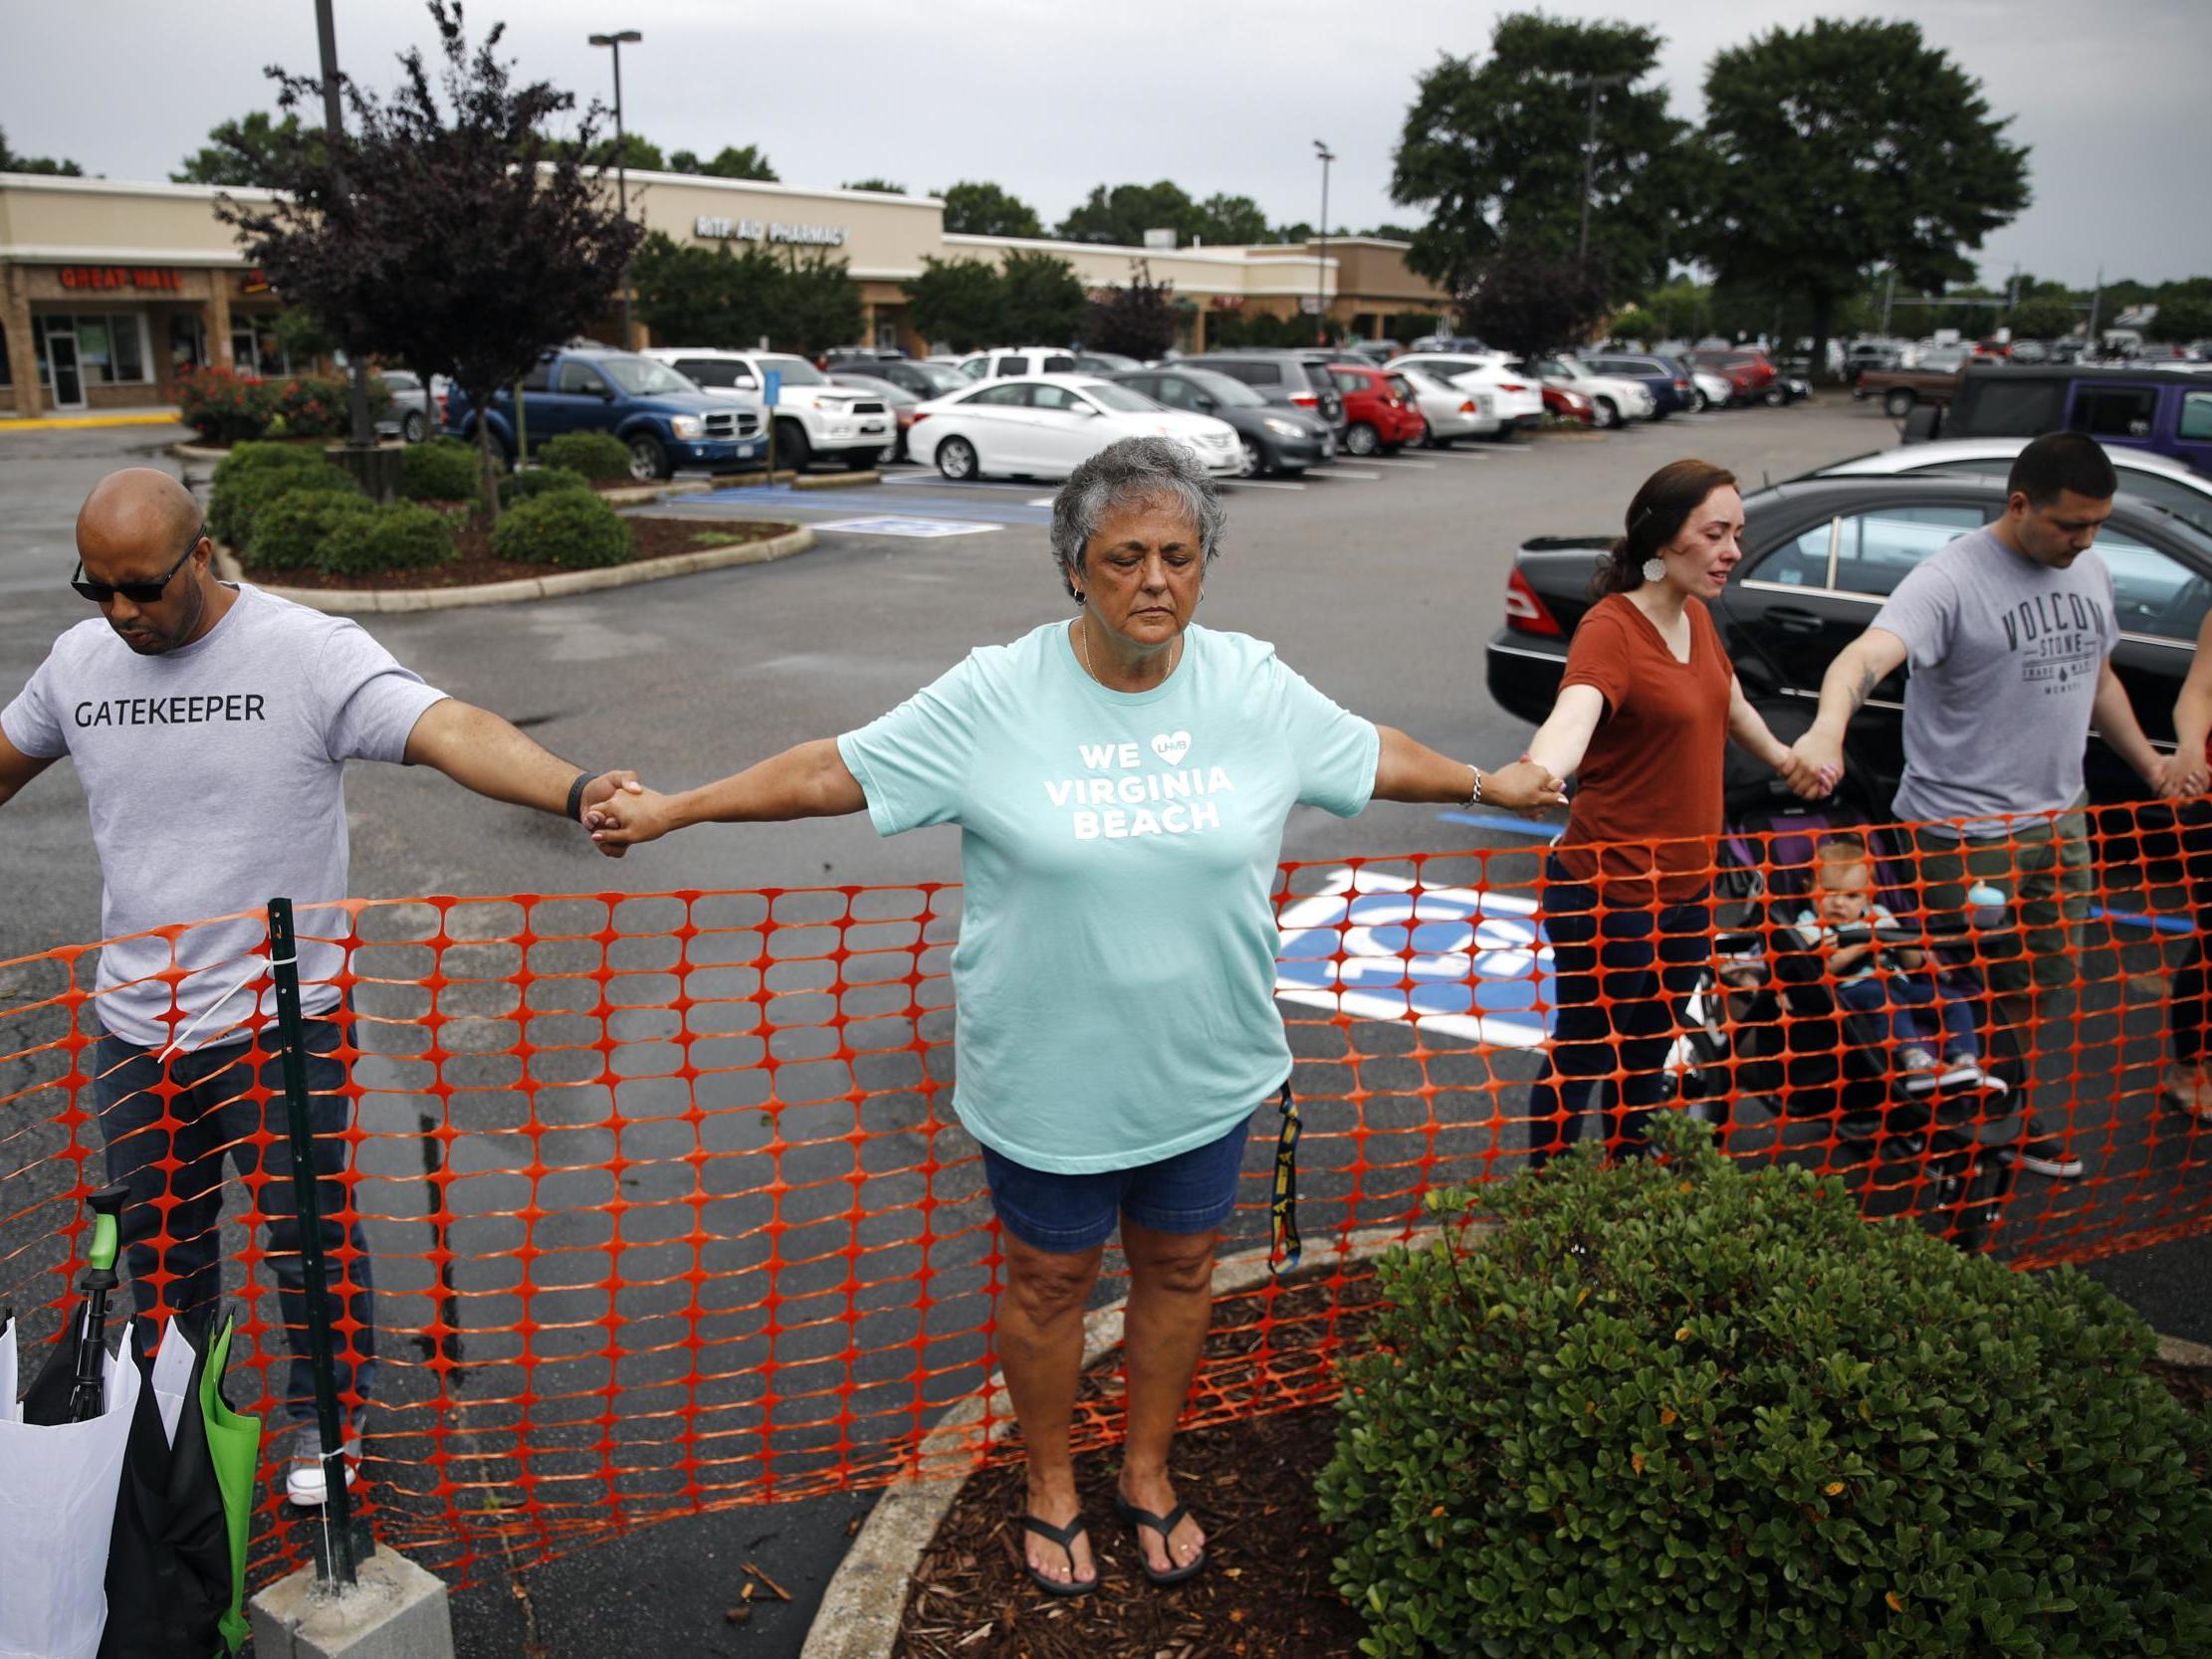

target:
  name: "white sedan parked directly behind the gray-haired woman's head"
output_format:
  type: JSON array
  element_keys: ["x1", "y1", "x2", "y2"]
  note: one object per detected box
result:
[{"x1": 907, "y1": 374, "x2": 1243, "y2": 480}]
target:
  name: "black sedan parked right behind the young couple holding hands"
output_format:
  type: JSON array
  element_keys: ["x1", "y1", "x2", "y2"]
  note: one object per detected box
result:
[{"x1": 1486, "y1": 478, "x2": 2212, "y2": 803}]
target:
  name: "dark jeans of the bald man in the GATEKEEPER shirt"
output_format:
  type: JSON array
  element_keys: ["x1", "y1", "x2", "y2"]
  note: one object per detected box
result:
[{"x1": 93, "y1": 1017, "x2": 376, "y2": 1424}]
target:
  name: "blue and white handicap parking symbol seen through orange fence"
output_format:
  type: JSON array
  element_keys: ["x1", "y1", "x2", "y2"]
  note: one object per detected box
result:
[{"x1": 1274, "y1": 870, "x2": 1553, "y2": 1049}]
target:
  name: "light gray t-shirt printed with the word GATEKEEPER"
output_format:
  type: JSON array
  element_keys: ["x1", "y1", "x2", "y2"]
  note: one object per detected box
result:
[{"x1": 0, "y1": 582, "x2": 445, "y2": 1049}]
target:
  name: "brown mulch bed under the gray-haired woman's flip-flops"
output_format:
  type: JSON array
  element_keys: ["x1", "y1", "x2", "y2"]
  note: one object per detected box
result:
[{"x1": 894, "y1": 1281, "x2": 1372, "y2": 1659}]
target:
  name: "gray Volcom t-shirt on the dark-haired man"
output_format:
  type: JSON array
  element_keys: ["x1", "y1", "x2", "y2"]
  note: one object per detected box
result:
[{"x1": 1874, "y1": 526, "x2": 2119, "y2": 836}]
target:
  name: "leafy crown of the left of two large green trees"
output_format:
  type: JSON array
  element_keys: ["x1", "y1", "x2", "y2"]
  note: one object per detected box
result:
[{"x1": 1392, "y1": 11, "x2": 1694, "y2": 299}]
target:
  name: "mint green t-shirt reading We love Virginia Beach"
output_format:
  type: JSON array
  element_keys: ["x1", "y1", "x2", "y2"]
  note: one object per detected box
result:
[{"x1": 838, "y1": 622, "x2": 1381, "y2": 1174}]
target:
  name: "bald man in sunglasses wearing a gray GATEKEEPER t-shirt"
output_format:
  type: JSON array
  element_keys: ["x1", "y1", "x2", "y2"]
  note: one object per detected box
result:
[{"x1": 0, "y1": 467, "x2": 635, "y2": 1504}]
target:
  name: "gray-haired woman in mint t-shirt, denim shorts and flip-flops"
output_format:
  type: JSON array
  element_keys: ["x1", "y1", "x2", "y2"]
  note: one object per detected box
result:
[{"x1": 595, "y1": 438, "x2": 1562, "y2": 1595}]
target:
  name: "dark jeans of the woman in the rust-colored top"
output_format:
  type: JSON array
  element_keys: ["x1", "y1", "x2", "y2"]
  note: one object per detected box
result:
[{"x1": 1528, "y1": 856, "x2": 1712, "y2": 1165}]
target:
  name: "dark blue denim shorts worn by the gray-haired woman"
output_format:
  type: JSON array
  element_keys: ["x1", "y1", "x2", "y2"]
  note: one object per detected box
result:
[{"x1": 983, "y1": 1113, "x2": 1252, "y2": 1256}]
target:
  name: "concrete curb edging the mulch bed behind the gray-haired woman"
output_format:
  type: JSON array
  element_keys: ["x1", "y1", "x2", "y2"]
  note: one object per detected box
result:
[{"x1": 798, "y1": 1223, "x2": 1488, "y2": 1659}]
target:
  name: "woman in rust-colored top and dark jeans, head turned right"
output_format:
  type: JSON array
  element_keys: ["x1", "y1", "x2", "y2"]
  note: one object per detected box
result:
[{"x1": 1526, "y1": 460, "x2": 1825, "y2": 1163}]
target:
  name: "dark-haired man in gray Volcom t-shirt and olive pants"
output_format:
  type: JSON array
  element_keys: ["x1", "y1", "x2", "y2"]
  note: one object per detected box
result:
[{"x1": 1794, "y1": 431, "x2": 2181, "y2": 1179}]
